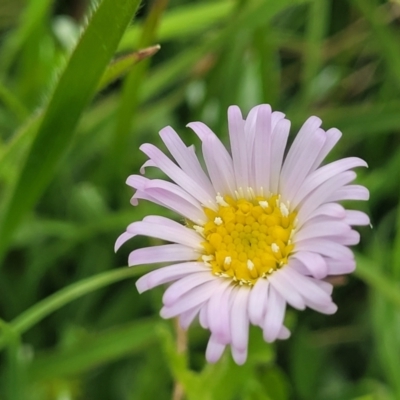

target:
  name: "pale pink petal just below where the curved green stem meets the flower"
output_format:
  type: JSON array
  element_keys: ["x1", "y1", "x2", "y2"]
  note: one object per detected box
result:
[{"x1": 136, "y1": 262, "x2": 208, "y2": 293}]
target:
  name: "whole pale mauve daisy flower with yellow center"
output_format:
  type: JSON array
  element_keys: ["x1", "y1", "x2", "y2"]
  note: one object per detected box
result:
[{"x1": 115, "y1": 105, "x2": 369, "y2": 364}]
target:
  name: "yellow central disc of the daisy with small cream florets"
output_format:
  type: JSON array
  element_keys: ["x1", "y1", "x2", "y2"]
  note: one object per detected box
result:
[{"x1": 193, "y1": 195, "x2": 296, "y2": 286}]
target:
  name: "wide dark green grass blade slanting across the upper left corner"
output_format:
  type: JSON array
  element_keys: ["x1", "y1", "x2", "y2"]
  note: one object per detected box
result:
[{"x1": 0, "y1": 0, "x2": 139, "y2": 257}]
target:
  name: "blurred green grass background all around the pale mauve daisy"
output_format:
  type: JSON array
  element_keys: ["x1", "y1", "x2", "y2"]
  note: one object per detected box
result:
[{"x1": 0, "y1": 0, "x2": 400, "y2": 400}]
